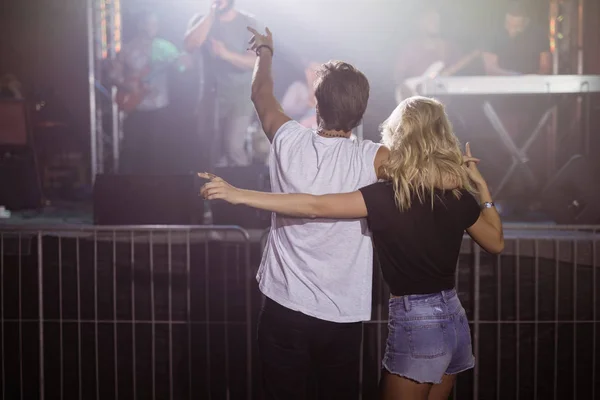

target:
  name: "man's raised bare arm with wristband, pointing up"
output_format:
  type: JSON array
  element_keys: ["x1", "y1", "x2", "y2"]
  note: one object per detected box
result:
[{"x1": 248, "y1": 28, "x2": 291, "y2": 142}]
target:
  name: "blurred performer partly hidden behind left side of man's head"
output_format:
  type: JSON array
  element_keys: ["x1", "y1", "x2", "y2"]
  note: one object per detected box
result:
[{"x1": 281, "y1": 62, "x2": 320, "y2": 129}]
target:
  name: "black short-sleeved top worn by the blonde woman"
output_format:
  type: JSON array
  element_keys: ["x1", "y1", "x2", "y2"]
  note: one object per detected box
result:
[{"x1": 360, "y1": 182, "x2": 480, "y2": 296}]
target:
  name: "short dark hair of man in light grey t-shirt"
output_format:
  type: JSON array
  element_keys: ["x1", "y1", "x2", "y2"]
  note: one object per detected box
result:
[{"x1": 315, "y1": 61, "x2": 370, "y2": 132}]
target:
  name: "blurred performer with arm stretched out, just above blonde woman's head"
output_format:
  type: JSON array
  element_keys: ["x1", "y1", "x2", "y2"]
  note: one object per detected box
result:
[{"x1": 394, "y1": 6, "x2": 479, "y2": 103}]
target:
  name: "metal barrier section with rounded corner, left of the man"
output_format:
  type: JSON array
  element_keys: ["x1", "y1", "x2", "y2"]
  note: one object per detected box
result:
[{"x1": 0, "y1": 226, "x2": 254, "y2": 400}]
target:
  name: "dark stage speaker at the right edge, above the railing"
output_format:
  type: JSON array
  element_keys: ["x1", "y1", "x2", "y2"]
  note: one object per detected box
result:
[{"x1": 542, "y1": 155, "x2": 600, "y2": 225}]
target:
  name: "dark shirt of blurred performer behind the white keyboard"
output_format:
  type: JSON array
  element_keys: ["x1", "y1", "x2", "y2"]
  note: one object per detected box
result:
[{"x1": 488, "y1": 25, "x2": 550, "y2": 74}]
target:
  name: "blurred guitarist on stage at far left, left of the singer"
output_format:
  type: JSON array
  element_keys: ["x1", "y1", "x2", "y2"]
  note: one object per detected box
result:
[{"x1": 109, "y1": 12, "x2": 189, "y2": 174}]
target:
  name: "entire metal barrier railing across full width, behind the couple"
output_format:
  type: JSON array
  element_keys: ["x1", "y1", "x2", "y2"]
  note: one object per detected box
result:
[{"x1": 0, "y1": 225, "x2": 600, "y2": 400}]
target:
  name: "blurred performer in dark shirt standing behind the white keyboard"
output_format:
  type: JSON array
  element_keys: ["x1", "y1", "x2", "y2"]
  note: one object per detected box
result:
[{"x1": 483, "y1": 2, "x2": 552, "y2": 75}]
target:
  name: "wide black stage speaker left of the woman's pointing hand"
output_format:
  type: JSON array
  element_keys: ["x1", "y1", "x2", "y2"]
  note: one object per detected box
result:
[{"x1": 94, "y1": 175, "x2": 203, "y2": 225}]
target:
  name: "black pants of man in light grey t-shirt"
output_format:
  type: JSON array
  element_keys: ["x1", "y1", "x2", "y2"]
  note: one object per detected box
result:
[{"x1": 258, "y1": 298, "x2": 362, "y2": 400}]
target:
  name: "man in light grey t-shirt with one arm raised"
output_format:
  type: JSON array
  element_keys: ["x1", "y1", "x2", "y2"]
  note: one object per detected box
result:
[{"x1": 248, "y1": 28, "x2": 389, "y2": 400}]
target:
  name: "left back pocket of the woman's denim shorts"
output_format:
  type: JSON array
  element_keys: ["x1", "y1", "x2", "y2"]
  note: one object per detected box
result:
[{"x1": 407, "y1": 323, "x2": 447, "y2": 358}]
